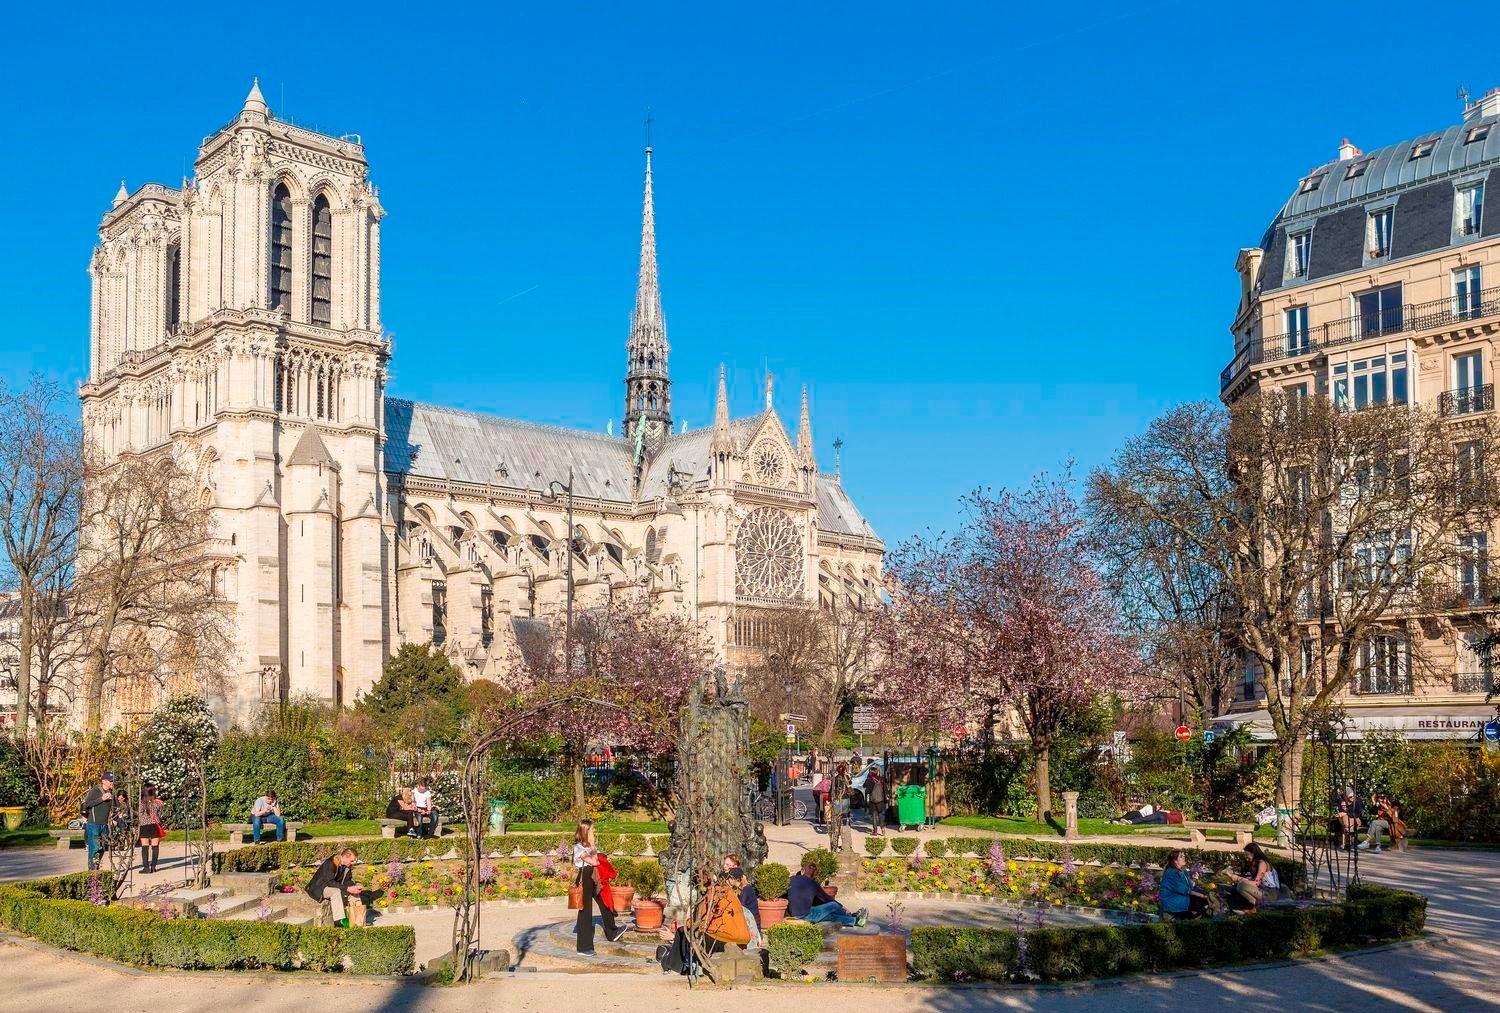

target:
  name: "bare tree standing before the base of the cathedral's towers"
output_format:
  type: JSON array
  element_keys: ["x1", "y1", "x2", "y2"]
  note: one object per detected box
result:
[{"x1": 74, "y1": 450, "x2": 233, "y2": 732}]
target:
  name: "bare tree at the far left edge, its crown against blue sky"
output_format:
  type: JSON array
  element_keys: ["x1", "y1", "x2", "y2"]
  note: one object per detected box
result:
[{"x1": 0, "y1": 377, "x2": 83, "y2": 737}]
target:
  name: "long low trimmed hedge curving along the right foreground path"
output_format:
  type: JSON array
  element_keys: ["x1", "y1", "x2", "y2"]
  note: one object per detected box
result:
[{"x1": 912, "y1": 885, "x2": 1427, "y2": 981}]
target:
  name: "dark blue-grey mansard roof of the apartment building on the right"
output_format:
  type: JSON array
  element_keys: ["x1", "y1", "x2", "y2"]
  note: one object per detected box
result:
[{"x1": 1260, "y1": 109, "x2": 1500, "y2": 291}]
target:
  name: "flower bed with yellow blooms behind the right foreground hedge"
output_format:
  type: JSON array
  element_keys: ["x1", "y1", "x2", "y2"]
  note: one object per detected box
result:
[{"x1": 861, "y1": 858, "x2": 1157, "y2": 912}]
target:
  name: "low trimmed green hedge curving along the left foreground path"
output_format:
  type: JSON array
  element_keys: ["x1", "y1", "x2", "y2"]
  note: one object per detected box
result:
[{"x1": 0, "y1": 873, "x2": 417, "y2": 974}]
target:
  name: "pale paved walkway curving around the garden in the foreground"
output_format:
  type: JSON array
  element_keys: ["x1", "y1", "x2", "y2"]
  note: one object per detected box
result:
[{"x1": 0, "y1": 831, "x2": 1500, "y2": 1013}]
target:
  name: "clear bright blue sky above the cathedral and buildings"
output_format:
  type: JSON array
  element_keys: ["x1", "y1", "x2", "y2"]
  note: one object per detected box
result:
[{"x1": 0, "y1": 2, "x2": 1500, "y2": 543}]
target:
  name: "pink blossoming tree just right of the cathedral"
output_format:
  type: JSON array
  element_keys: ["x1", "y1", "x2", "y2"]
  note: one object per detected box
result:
[{"x1": 879, "y1": 474, "x2": 1140, "y2": 816}]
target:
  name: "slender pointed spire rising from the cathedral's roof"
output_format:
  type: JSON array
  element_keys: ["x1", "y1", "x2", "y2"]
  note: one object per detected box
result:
[{"x1": 624, "y1": 146, "x2": 672, "y2": 447}]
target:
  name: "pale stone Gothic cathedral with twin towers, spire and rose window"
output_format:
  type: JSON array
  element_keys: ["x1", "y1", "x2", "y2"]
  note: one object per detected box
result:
[{"x1": 80, "y1": 87, "x2": 884, "y2": 719}]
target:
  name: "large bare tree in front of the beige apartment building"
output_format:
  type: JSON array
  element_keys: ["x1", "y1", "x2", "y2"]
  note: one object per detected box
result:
[{"x1": 1092, "y1": 392, "x2": 1496, "y2": 828}]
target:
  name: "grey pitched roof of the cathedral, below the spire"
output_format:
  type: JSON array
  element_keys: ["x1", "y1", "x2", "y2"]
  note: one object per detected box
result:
[{"x1": 386, "y1": 398, "x2": 875, "y2": 537}]
